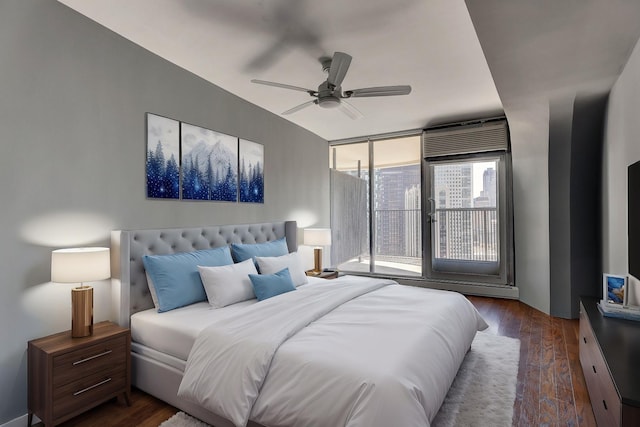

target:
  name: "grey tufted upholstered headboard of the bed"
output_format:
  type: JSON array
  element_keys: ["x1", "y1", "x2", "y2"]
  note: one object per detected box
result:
[{"x1": 111, "y1": 221, "x2": 298, "y2": 327}]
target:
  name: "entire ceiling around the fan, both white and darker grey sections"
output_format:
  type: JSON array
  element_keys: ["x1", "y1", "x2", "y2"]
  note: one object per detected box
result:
[{"x1": 53, "y1": 0, "x2": 640, "y2": 144}]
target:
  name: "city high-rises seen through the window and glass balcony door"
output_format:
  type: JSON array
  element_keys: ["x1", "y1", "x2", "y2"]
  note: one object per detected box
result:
[{"x1": 336, "y1": 148, "x2": 498, "y2": 275}]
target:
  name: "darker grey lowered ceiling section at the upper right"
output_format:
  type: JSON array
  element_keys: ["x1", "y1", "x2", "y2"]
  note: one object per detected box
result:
[{"x1": 466, "y1": 0, "x2": 640, "y2": 109}]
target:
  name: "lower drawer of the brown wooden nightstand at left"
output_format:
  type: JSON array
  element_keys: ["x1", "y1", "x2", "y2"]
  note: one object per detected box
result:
[{"x1": 53, "y1": 365, "x2": 127, "y2": 424}]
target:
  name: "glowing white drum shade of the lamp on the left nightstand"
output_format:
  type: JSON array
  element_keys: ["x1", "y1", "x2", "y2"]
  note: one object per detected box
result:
[{"x1": 51, "y1": 248, "x2": 111, "y2": 283}]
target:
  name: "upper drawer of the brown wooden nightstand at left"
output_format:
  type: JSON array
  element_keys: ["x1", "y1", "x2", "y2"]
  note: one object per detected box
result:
[{"x1": 53, "y1": 336, "x2": 127, "y2": 387}]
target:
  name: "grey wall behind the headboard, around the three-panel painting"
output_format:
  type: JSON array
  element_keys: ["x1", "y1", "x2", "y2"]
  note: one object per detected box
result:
[{"x1": 0, "y1": 0, "x2": 329, "y2": 424}]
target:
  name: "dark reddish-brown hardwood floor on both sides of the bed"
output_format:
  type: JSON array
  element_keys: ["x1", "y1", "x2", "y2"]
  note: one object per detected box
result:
[{"x1": 48, "y1": 297, "x2": 596, "y2": 427}]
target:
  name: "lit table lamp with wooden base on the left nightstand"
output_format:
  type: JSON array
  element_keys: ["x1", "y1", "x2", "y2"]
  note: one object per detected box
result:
[{"x1": 51, "y1": 248, "x2": 111, "y2": 338}]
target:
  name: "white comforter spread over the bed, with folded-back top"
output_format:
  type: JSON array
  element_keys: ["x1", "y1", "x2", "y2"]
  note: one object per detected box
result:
[{"x1": 178, "y1": 276, "x2": 487, "y2": 427}]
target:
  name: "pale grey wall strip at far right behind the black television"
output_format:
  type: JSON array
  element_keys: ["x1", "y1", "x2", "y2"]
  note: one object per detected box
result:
[{"x1": 602, "y1": 38, "x2": 640, "y2": 280}]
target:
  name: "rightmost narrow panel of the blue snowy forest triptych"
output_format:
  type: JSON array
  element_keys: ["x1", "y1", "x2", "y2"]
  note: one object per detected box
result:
[{"x1": 240, "y1": 139, "x2": 264, "y2": 203}]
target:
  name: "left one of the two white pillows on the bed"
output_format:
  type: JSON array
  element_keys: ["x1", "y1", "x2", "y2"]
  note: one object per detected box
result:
[{"x1": 198, "y1": 259, "x2": 258, "y2": 308}]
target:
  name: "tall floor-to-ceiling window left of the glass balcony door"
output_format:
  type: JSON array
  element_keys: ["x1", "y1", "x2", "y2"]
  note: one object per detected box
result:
[{"x1": 330, "y1": 134, "x2": 423, "y2": 277}]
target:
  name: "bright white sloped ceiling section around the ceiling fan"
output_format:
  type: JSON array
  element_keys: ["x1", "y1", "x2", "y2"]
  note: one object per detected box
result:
[{"x1": 59, "y1": 0, "x2": 503, "y2": 140}]
